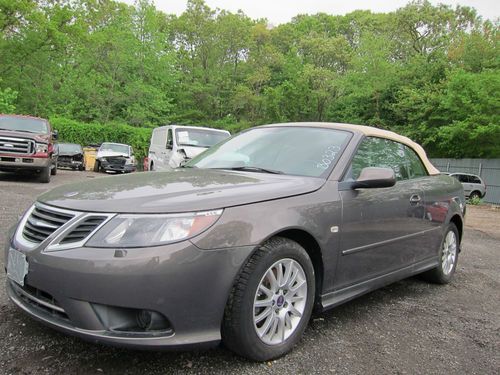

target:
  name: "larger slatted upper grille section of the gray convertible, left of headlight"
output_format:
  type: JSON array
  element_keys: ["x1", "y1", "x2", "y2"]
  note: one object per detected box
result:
[{"x1": 23, "y1": 206, "x2": 75, "y2": 243}]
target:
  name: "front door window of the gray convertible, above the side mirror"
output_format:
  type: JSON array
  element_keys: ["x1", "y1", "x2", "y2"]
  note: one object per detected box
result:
[{"x1": 347, "y1": 137, "x2": 409, "y2": 181}]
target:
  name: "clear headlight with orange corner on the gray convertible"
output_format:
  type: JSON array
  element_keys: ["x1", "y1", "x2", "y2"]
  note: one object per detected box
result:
[{"x1": 86, "y1": 210, "x2": 222, "y2": 247}]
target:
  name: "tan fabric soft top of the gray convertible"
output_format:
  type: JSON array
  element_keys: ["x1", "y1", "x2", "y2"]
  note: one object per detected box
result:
[{"x1": 264, "y1": 122, "x2": 439, "y2": 175}]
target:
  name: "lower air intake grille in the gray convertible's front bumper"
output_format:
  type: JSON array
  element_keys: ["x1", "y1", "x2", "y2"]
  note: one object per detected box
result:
[{"x1": 10, "y1": 281, "x2": 69, "y2": 320}]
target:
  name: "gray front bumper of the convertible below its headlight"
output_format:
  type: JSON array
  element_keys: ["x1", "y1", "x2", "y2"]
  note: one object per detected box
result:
[{"x1": 5, "y1": 241, "x2": 253, "y2": 348}]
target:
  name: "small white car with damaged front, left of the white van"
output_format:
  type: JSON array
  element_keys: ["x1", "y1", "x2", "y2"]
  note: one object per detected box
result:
[{"x1": 95, "y1": 142, "x2": 135, "y2": 173}]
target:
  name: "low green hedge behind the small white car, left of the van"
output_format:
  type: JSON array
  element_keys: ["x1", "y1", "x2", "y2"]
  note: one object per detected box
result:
[{"x1": 50, "y1": 117, "x2": 153, "y2": 162}]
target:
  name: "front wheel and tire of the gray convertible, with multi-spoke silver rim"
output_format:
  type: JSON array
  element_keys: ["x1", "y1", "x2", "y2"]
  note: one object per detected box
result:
[{"x1": 222, "y1": 237, "x2": 315, "y2": 361}]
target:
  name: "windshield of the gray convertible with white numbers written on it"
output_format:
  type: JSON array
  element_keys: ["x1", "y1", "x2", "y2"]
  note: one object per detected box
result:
[{"x1": 186, "y1": 126, "x2": 350, "y2": 177}]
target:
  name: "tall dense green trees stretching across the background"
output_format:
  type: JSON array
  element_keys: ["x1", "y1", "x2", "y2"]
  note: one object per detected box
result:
[{"x1": 0, "y1": 0, "x2": 500, "y2": 157}]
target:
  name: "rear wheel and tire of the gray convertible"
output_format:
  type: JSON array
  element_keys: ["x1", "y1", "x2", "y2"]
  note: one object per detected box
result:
[{"x1": 422, "y1": 223, "x2": 460, "y2": 284}]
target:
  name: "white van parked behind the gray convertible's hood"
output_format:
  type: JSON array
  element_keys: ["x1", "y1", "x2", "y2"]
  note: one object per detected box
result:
[{"x1": 148, "y1": 125, "x2": 231, "y2": 171}]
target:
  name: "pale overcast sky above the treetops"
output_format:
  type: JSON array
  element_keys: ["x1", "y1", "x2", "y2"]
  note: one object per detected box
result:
[{"x1": 120, "y1": 0, "x2": 500, "y2": 25}]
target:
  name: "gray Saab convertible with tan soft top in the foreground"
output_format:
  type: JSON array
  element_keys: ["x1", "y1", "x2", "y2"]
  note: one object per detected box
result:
[{"x1": 5, "y1": 123, "x2": 465, "y2": 360}]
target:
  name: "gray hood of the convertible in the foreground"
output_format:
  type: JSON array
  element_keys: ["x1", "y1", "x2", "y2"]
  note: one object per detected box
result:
[{"x1": 38, "y1": 169, "x2": 325, "y2": 213}]
